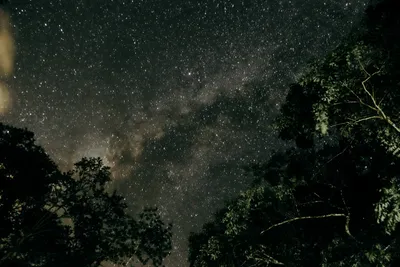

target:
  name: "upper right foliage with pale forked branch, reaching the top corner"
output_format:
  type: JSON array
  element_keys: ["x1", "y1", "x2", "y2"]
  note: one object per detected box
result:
[{"x1": 278, "y1": 0, "x2": 400, "y2": 154}]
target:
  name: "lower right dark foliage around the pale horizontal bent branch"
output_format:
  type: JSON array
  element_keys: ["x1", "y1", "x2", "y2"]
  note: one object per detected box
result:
[{"x1": 189, "y1": 143, "x2": 400, "y2": 266}]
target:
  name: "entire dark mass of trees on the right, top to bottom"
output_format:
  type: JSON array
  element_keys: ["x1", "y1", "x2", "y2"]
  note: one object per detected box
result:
[{"x1": 189, "y1": 0, "x2": 400, "y2": 266}]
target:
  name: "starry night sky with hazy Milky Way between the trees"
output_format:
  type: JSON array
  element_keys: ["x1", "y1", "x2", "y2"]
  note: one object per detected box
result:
[{"x1": 0, "y1": 0, "x2": 367, "y2": 267}]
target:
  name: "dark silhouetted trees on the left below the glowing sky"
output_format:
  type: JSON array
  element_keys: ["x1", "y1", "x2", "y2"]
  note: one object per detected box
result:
[{"x1": 0, "y1": 124, "x2": 171, "y2": 267}]
